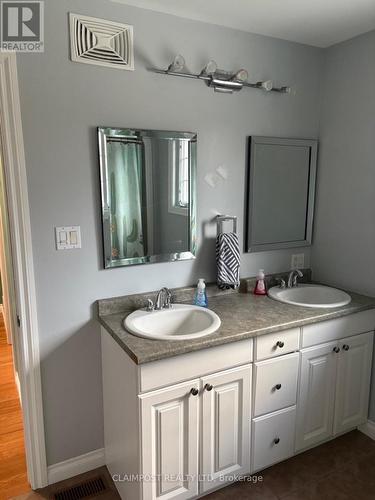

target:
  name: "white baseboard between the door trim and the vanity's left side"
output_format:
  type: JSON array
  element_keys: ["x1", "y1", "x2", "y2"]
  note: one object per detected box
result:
[{"x1": 48, "y1": 448, "x2": 105, "y2": 484}]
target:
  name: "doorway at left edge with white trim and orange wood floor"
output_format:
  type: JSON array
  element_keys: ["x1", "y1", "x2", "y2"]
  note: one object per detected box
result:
[{"x1": 0, "y1": 51, "x2": 47, "y2": 492}]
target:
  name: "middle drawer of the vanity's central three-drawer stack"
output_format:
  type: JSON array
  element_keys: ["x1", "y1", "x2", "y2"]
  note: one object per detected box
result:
[{"x1": 254, "y1": 352, "x2": 299, "y2": 417}]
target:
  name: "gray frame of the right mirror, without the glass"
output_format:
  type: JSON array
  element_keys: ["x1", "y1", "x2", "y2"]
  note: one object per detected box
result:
[{"x1": 245, "y1": 136, "x2": 318, "y2": 253}]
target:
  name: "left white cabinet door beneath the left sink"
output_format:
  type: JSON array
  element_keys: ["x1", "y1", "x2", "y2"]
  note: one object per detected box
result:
[{"x1": 140, "y1": 379, "x2": 199, "y2": 500}]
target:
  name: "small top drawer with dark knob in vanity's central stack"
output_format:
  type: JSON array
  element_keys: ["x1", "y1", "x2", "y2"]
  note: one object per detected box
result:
[{"x1": 255, "y1": 328, "x2": 300, "y2": 361}]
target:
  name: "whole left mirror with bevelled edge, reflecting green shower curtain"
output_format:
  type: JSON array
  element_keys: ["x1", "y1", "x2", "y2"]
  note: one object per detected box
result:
[{"x1": 98, "y1": 127, "x2": 197, "y2": 268}]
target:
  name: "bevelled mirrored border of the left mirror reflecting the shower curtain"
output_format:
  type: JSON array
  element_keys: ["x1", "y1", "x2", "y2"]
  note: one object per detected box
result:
[{"x1": 97, "y1": 127, "x2": 198, "y2": 269}]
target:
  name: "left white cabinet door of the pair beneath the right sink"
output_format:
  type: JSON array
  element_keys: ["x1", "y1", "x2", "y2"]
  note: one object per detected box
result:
[{"x1": 296, "y1": 342, "x2": 339, "y2": 451}]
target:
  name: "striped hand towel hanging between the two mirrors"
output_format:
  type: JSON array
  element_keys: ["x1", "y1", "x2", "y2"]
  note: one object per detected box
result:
[{"x1": 216, "y1": 233, "x2": 240, "y2": 290}]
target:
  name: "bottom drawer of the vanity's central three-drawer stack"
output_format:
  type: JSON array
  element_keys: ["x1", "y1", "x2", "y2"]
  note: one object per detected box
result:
[{"x1": 252, "y1": 406, "x2": 296, "y2": 471}]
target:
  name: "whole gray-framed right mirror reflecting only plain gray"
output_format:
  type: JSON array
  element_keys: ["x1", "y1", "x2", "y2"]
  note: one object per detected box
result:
[{"x1": 246, "y1": 136, "x2": 318, "y2": 252}]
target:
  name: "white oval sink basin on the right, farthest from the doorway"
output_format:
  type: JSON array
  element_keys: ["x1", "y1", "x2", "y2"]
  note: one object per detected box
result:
[{"x1": 268, "y1": 285, "x2": 352, "y2": 308}]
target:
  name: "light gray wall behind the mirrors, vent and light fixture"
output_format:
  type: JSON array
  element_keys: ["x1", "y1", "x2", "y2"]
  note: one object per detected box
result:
[{"x1": 18, "y1": 0, "x2": 322, "y2": 464}]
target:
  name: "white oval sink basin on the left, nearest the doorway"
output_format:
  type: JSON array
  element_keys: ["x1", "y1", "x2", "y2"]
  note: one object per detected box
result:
[{"x1": 124, "y1": 304, "x2": 221, "y2": 340}]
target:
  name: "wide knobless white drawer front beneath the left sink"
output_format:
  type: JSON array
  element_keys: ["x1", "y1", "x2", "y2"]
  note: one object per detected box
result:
[{"x1": 139, "y1": 339, "x2": 253, "y2": 392}]
